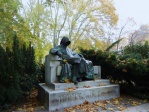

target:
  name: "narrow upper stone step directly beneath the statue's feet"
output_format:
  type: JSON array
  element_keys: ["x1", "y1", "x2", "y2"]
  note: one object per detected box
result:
[{"x1": 48, "y1": 79, "x2": 110, "y2": 90}]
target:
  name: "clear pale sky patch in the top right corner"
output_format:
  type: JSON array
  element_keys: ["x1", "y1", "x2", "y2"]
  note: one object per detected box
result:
[{"x1": 113, "y1": 0, "x2": 149, "y2": 26}]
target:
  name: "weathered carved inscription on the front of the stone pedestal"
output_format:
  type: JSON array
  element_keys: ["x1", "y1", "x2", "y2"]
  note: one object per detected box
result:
[{"x1": 50, "y1": 88, "x2": 117, "y2": 106}]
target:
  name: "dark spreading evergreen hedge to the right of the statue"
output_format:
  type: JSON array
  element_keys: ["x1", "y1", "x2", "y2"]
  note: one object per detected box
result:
[{"x1": 80, "y1": 46, "x2": 149, "y2": 99}]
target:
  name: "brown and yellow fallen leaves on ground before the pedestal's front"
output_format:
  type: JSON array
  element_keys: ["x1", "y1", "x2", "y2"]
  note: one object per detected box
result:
[{"x1": 64, "y1": 97, "x2": 146, "y2": 112}]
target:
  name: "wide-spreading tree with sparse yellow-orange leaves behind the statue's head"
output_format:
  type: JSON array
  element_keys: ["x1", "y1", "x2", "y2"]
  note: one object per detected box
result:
[{"x1": 45, "y1": 0, "x2": 118, "y2": 48}]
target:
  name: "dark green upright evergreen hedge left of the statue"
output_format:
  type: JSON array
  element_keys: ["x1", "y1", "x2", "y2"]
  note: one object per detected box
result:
[{"x1": 0, "y1": 35, "x2": 42, "y2": 110}]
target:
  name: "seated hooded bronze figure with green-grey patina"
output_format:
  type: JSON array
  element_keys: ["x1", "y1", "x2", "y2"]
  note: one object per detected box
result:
[{"x1": 50, "y1": 37, "x2": 94, "y2": 84}]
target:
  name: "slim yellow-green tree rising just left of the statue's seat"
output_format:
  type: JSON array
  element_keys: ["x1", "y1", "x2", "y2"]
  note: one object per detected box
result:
[{"x1": 22, "y1": 0, "x2": 52, "y2": 63}]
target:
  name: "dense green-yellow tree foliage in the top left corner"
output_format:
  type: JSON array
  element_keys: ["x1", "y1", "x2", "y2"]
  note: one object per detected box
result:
[{"x1": 0, "y1": 0, "x2": 32, "y2": 48}]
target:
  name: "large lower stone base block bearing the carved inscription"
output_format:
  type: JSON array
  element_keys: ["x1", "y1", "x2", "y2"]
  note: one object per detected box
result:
[{"x1": 38, "y1": 81, "x2": 120, "y2": 111}]
